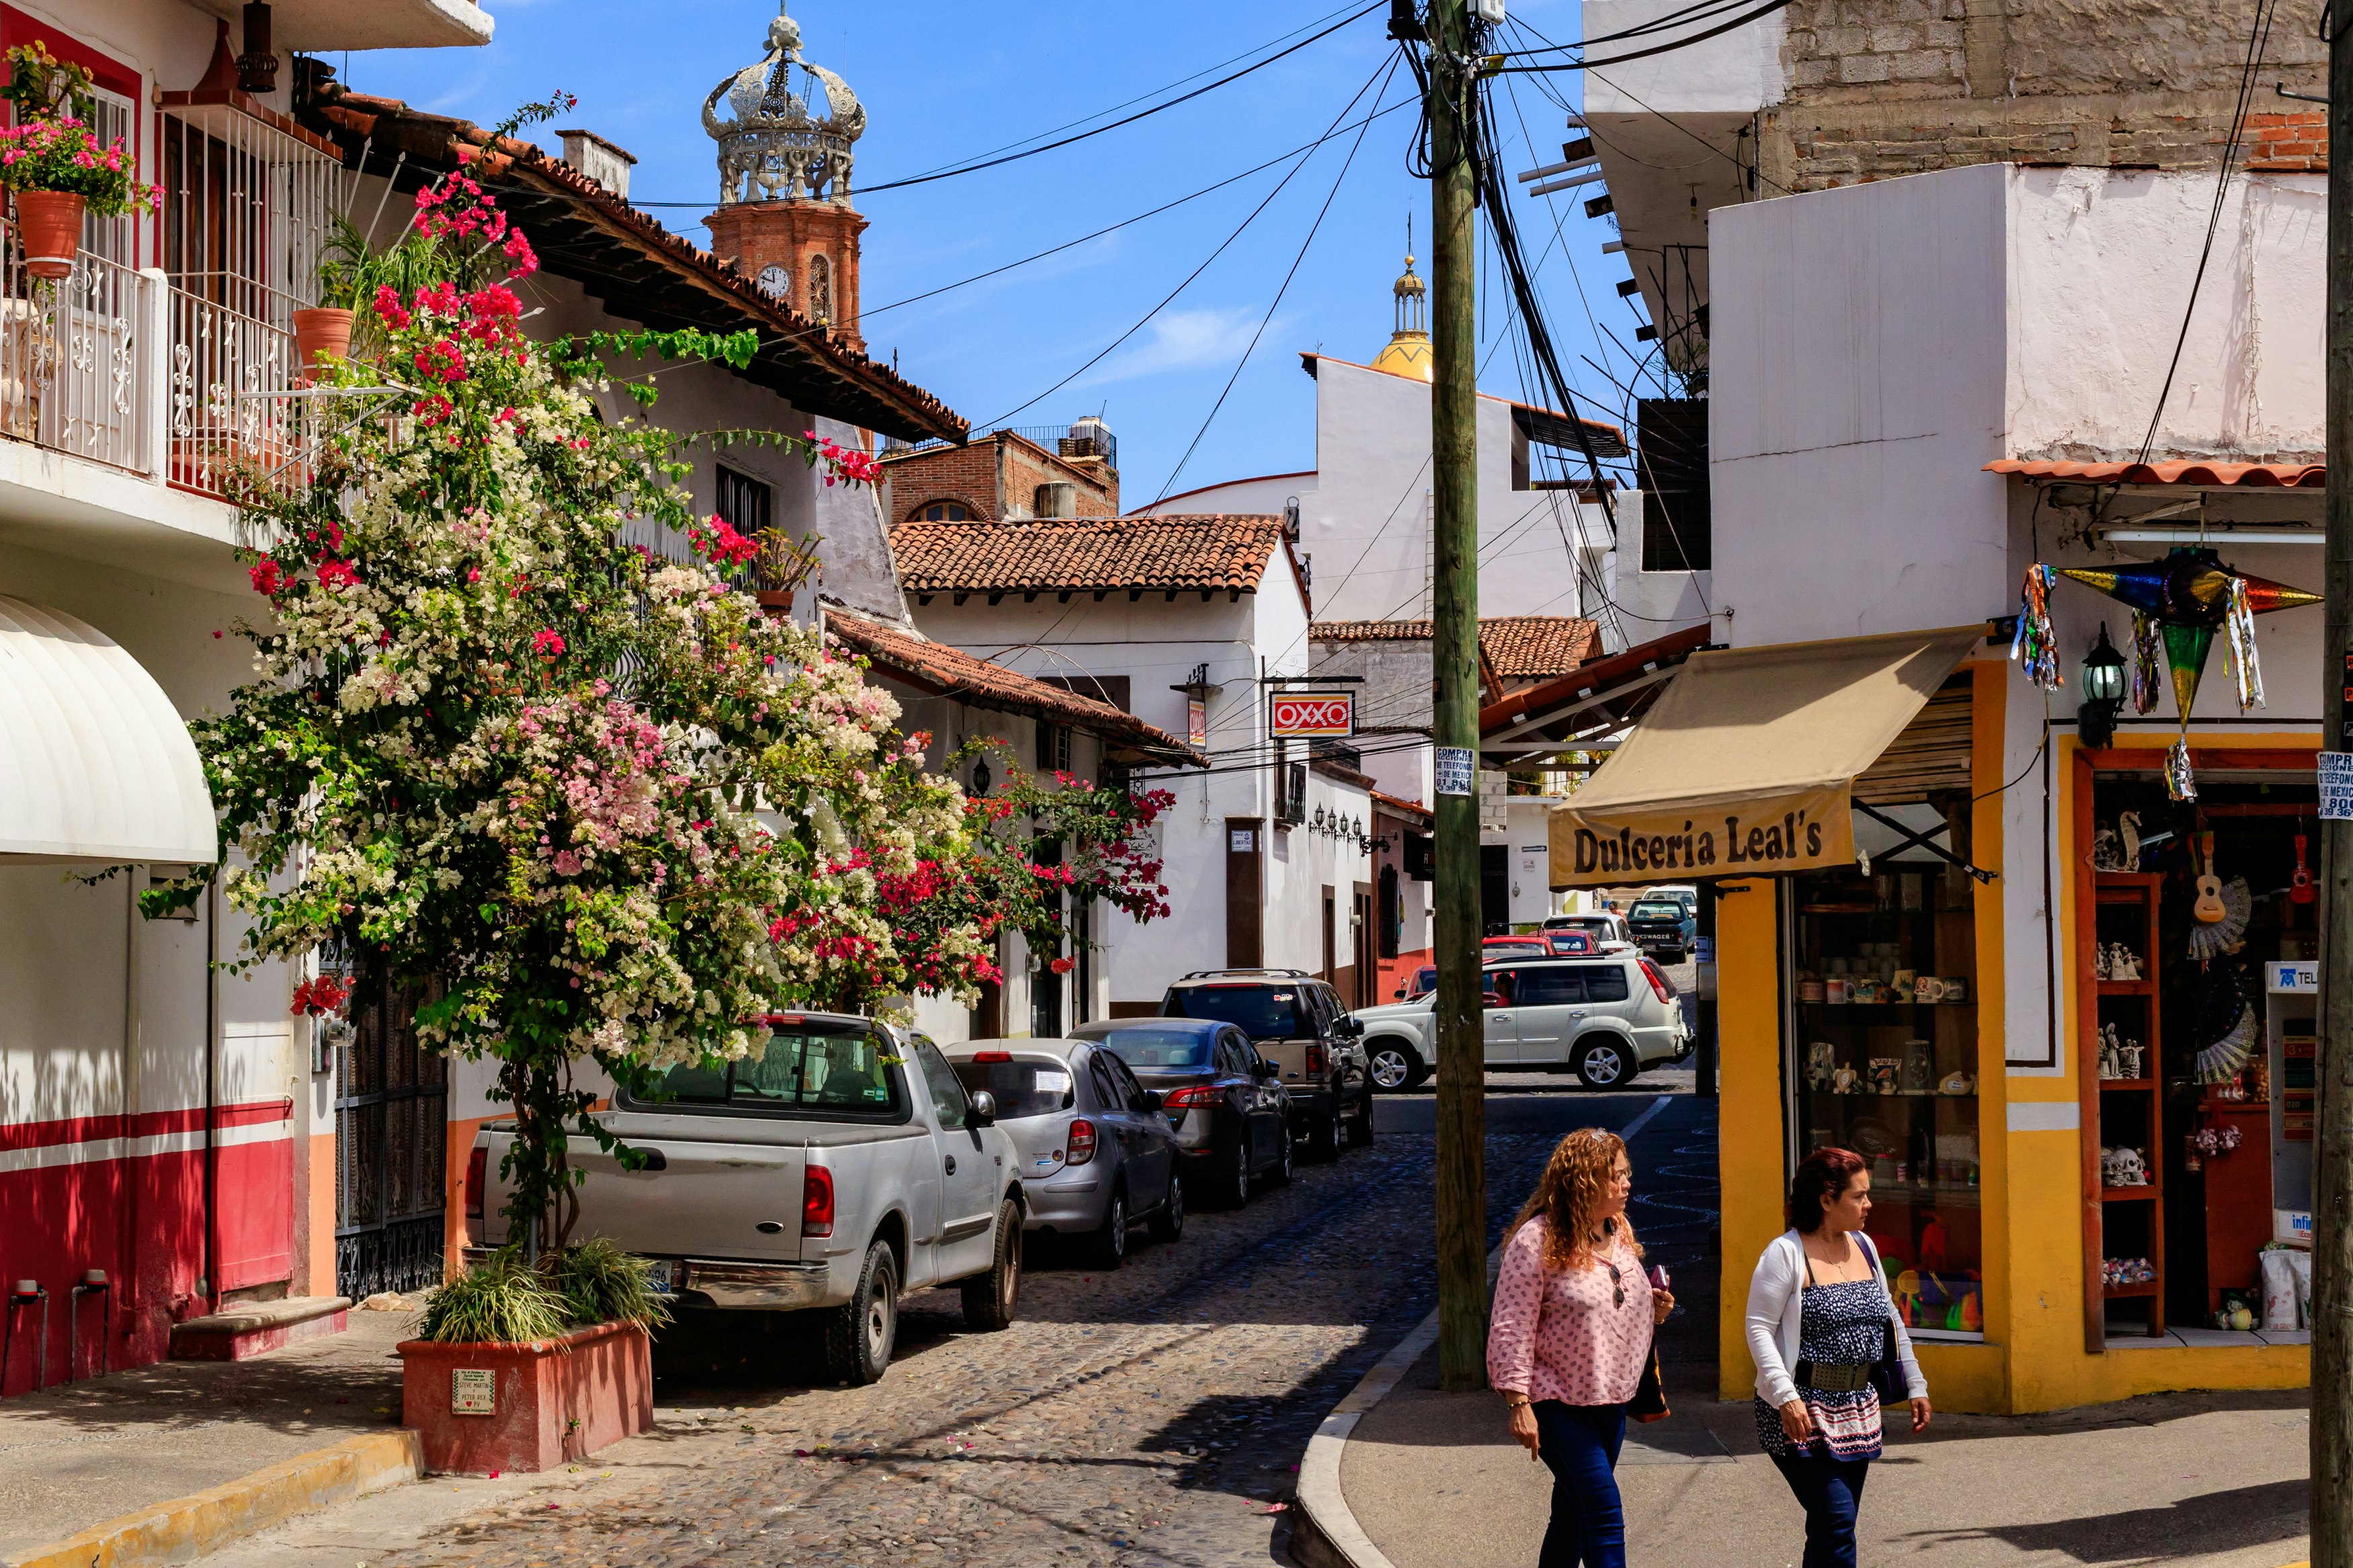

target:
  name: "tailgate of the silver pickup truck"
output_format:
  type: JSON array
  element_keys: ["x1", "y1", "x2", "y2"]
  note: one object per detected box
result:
[{"x1": 485, "y1": 1114, "x2": 824, "y2": 1262}]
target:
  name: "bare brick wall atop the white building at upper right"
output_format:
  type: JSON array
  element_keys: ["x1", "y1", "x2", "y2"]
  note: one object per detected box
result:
[{"x1": 1758, "y1": 0, "x2": 2325, "y2": 190}]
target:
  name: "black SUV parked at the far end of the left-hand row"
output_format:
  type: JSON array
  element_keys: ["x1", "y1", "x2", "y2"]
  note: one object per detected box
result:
[{"x1": 1160, "y1": 968, "x2": 1372, "y2": 1159}]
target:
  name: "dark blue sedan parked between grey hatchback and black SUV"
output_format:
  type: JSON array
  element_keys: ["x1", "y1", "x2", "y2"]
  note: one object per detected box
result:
[{"x1": 1073, "y1": 1018, "x2": 1292, "y2": 1208}]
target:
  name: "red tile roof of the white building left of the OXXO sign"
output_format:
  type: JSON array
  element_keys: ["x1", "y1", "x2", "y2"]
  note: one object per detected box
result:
[{"x1": 889, "y1": 515, "x2": 1285, "y2": 595}]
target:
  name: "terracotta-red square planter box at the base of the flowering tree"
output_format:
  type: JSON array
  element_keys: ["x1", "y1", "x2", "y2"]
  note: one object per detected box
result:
[{"x1": 400, "y1": 1323, "x2": 654, "y2": 1477}]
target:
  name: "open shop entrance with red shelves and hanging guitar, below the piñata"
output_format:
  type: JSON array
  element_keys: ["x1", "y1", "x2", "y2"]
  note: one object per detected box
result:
[{"x1": 2075, "y1": 752, "x2": 2318, "y2": 1340}]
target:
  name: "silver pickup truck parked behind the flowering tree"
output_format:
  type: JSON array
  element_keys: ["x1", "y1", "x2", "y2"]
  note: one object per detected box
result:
[{"x1": 466, "y1": 1014, "x2": 1024, "y2": 1383}]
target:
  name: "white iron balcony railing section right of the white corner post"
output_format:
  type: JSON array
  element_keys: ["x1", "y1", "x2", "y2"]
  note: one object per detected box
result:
[{"x1": 167, "y1": 284, "x2": 311, "y2": 496}]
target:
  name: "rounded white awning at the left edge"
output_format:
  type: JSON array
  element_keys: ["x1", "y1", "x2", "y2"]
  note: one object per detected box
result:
[{"x1": 0, "y1": 595, "x2": 219, "y2": 865}]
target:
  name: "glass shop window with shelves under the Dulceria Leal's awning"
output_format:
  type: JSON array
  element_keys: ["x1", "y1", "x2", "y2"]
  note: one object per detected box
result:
[{"x1": 1786, "y1": 865, "x2": 1986, "y2": 1337}]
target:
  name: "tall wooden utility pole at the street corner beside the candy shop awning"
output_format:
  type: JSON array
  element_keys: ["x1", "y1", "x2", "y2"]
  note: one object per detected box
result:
[{"x1": 1426, "y1": 0, "x2": 1487, "y2": 1389}]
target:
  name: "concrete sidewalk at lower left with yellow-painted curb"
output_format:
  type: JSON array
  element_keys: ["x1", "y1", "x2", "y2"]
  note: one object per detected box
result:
[{"x1": 0, "y1": 1312, "x2": 414, "y2": 1561}]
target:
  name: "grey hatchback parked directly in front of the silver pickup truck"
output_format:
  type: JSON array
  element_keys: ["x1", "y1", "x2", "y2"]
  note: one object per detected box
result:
[{"x1": 946, "y1": 1039, "x2": 1184, "y2": 1270}]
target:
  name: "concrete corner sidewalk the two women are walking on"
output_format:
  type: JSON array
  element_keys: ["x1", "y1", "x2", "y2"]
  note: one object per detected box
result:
[{"x1": 1339, "y1": 1352, "x2": 2309, "y2": 1568}]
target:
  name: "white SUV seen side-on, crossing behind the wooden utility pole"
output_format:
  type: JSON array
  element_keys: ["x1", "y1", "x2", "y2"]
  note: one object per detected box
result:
[{"x1": 1353, "y1": 952, "x2": 1689, "y2": 1088}]
